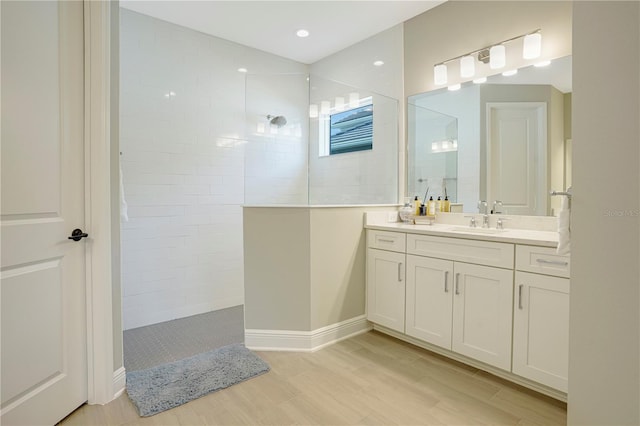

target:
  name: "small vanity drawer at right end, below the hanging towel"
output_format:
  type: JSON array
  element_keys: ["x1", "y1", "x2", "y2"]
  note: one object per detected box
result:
[{"x1": 516, "y1": 245, "x2": 571, "y2": 278}]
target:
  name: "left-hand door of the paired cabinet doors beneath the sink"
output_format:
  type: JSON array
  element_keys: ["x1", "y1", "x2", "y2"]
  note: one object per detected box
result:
[{"x1": 405, "y1": 255, "x2": 453, "y2": 350}]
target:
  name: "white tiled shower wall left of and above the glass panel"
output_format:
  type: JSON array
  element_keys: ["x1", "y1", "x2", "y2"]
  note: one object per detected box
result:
[{"x1": 120, "y1": 9, "x2": 308, "y2": 329}]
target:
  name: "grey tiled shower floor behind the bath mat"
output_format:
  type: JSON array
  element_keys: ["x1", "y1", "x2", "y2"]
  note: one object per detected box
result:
[{"x1": 123, "y1": 305, "x2": 244, "y2": 371}]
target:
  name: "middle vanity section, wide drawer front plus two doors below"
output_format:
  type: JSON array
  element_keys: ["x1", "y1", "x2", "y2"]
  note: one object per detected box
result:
[{"x1": 406, "y1": 234, "x2": 514, "y2": 370}]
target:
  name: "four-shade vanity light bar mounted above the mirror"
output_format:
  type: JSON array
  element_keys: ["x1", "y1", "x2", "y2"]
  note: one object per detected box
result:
[{"x1": 433, "y1": 28, "x2": 542, "y2": 86}]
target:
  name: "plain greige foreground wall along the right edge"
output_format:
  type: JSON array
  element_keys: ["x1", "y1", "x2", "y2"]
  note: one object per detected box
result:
[{"x1": 568, "y1": 1, "x2": 640, "y2": 425}]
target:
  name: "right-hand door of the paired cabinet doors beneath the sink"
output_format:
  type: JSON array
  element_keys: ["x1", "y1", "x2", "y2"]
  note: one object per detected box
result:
[{"x1": 452, "y1": 262, "x2": 513, "y2": 371}]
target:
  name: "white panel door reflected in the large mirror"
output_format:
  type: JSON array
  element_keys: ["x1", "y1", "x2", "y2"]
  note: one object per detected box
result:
[{"x1": 487, "y1": 102, "x2": 548, "y2": 215}]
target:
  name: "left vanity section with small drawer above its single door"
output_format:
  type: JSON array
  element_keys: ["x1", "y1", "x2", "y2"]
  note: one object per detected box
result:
[{"x1": 367, "y1": 231, "x2": 405, "y2": 333}]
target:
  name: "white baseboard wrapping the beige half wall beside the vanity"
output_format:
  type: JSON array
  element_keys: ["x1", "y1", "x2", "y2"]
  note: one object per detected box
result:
[{"x1": 244, "y1": 315, "x2": 373, "y2": 352}]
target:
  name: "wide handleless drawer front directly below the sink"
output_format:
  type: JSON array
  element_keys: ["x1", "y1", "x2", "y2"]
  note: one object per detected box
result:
[{"x1": 407, "y1": 234, "x2": 513, "y2": 269}]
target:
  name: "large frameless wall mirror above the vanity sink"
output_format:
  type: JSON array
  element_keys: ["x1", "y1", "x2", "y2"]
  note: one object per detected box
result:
[{"x1": 407, "y1": 56, "x2": 572, "y2": 216}]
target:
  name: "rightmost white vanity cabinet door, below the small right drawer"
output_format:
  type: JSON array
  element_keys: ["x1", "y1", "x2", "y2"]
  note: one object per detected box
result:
[{"x1": 513, "y1": 271, "x2": 569, "y2": 392}]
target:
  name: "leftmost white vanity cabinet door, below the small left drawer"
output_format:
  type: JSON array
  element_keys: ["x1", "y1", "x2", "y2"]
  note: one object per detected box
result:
[{"x1": 367, "y1": 248, "x2": 405, "y2": 333}]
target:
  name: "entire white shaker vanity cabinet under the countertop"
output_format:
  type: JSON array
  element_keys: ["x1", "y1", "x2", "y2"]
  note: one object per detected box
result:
[{"x1": 367, "y1": 226, "x2": 570, "y2": 401}]
